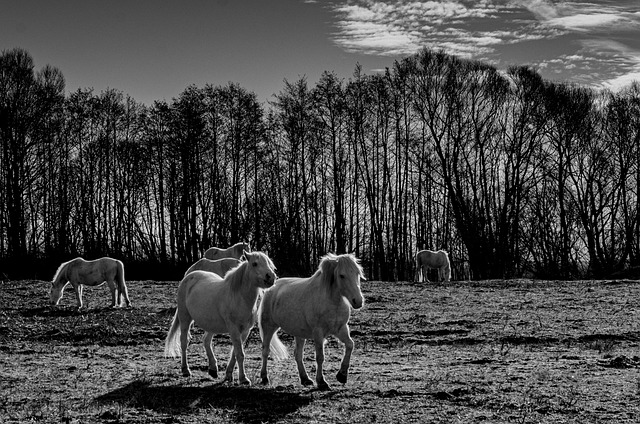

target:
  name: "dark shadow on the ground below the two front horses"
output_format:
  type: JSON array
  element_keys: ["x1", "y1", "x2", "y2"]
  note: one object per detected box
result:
[{"x1": 96, "y1": 380, "x2": 313, "y2": 423}]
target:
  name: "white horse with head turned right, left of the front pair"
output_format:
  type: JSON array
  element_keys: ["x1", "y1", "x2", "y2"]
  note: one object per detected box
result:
[{"x1": 164, "y1": 252, "x2": 276, "y2": 384}]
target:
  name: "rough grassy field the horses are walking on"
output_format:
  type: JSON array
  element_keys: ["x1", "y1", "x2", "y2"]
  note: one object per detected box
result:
[{"x1": 0, "y1": 280, "x2": 640, "y2": 423}]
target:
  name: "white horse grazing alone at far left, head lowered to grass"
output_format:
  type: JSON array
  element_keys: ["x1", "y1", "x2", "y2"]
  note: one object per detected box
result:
[{"x1": 49, "y1": 257, "x2": 131, "y2": 309}]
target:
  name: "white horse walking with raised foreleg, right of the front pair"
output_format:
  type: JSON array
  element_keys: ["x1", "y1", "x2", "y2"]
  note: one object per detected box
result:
[{"x1": 258, "y1": 254, "x2": 365, "y2": 390}]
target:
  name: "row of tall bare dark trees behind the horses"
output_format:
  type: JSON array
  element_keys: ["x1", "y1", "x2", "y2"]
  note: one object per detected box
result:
[{"x1": 0, "y1": 48, "x2": 640, "y2": 280}]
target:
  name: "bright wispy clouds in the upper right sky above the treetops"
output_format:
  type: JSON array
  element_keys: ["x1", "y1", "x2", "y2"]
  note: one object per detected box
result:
[{"x1": 330, "y1": 0, "x2": 640, "y2": 86}]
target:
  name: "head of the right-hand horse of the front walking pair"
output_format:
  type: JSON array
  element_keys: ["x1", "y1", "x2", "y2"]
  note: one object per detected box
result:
[{"x1": 320, "y1": 253, "x2": 366, "y2": 309}]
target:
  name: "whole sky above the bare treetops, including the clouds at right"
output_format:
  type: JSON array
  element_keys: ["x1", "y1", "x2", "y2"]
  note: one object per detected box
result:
[{"x1": 0, "y1": 0, "x2": 640, "y2": 105}]
